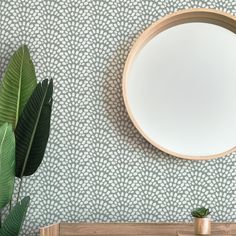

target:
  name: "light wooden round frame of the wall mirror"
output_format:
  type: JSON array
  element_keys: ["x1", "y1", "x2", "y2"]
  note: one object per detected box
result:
[{"x1": 122, "y1": 8, "x2": 236, "y2": 160}]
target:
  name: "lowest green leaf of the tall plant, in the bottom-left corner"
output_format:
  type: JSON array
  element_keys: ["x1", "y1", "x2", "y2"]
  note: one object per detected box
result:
[{"x1": 0, "y1": 197, "x2": 30, "y2": 236}]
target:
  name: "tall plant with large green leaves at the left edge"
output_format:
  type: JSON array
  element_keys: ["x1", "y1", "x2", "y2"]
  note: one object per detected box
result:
[{"x1": 0, "y1": 45, "x2": 53, "y2": 236}]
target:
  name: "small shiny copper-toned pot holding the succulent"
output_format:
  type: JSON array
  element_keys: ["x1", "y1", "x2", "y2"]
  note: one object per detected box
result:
[{"x1": 194, "y1": 217, "x2": 211, "y2": 235}]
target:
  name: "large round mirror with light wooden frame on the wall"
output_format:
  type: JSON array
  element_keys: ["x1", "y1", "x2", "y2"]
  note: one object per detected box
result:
[{"x1": 123, "y1": 9, "x2": 236, "y2": 160}]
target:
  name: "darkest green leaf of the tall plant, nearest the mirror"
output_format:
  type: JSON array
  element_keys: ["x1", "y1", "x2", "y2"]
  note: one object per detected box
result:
[{"x1": 15, "y1": 80, "x2": 53, "y2": 178}]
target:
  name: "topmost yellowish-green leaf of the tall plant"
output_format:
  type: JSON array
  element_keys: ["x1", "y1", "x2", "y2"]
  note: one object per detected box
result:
[{"x1": 0, "y1": 45, "x2": 37, "y2": 129}]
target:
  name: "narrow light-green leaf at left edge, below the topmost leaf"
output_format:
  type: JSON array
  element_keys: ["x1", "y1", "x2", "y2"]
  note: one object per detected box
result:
[{"x1": 0, "y1": 123, "x2": 15, "y2": 209}]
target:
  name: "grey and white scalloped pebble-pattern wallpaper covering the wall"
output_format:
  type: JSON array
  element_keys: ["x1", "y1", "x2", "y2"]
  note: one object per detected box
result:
[{"x1": 0, "y1": 0, "x2": 236, "y2": 235}]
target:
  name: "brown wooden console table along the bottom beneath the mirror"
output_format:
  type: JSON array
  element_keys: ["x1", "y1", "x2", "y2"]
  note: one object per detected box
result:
[{"x1": 40, "y1": 223, "x2": 236, "y2": 236}]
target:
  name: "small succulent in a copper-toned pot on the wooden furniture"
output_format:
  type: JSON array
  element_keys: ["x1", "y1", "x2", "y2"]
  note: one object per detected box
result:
[{"x1": 191, "y1": 207, "x2": 211, "y2": 235}]
